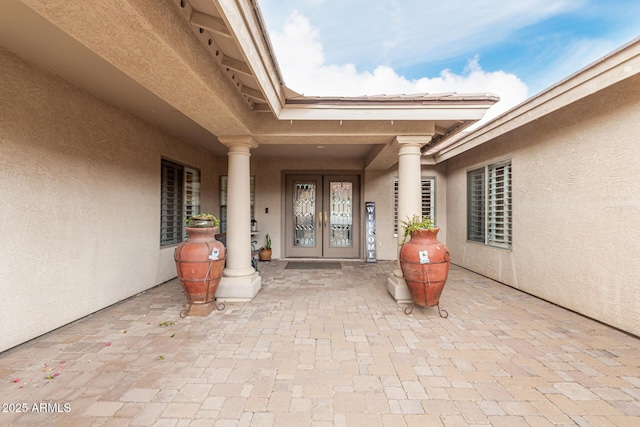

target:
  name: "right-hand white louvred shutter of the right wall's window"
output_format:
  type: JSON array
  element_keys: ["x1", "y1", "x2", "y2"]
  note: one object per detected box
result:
[{"x1": 487, "y1": 162, "x2": 511, "y2": 248}]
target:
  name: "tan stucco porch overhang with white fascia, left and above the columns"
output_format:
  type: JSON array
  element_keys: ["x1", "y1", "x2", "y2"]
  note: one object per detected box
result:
[{"x1": 0, "y1": 0, "x2": 497, "y2": 158}]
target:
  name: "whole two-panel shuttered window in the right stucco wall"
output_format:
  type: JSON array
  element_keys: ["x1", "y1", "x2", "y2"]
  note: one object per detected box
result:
[{"x1": 467, "y1": 160, "x2": 512, "y2": 248}]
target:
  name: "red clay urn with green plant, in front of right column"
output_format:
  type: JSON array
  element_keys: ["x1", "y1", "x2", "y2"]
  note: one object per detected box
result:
[{"x1": 399, "y1": 215, "x2": 450, "y2": 317}]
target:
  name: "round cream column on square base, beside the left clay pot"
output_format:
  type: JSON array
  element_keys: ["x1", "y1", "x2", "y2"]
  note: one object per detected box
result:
[{"x1": 216, "y1": 136, "x2": 260, "y2": 301}]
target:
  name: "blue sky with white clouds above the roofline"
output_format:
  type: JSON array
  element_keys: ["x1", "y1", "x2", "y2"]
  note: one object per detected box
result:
[{"x1": 258, "y1": 0, "x2": 640, "y2": 122}]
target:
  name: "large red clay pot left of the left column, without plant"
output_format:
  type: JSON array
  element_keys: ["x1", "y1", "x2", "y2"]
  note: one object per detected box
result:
[{"x1": 174, "y1": 227, "x2": 226, "y2": 316}]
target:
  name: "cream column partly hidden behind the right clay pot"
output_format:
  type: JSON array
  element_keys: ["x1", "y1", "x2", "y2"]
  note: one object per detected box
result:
[{"x1": 387, "y1": 135, "x2": 431, "y2": 302}]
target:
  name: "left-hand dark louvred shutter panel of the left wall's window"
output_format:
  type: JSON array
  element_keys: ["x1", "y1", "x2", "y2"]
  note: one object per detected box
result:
[{"x1": 160, "y1": 160, "x2": 183, "y2": 246}]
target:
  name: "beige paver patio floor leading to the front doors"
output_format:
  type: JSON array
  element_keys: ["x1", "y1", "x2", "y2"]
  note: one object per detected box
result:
[{"x1": 0, "y1": 261, "x2": 640, "y2": 427}]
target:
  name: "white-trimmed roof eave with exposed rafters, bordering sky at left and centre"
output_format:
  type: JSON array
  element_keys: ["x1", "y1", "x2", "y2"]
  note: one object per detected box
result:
[{"x1": 174, "y1": 0, "x2": 498, "y2": 151}]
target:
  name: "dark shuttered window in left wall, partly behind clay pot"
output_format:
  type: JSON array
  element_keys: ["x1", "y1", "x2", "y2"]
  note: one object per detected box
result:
[{"x1": 160, "y1": 159, "x2": 200, "y2": 246}]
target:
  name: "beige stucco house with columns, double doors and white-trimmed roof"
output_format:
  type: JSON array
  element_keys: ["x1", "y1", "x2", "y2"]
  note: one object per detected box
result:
[{"x1": 0, "y1": 0, "x2": 640, "y2": 351}]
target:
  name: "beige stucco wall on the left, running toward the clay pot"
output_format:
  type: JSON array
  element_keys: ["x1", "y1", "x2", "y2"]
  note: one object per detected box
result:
[{"x1": 0, "y1": 48, "x2": 224, "y2": 351}]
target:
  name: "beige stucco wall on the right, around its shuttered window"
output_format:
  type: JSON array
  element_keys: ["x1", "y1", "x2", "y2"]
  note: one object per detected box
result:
[{"x1": 447, "y1": 76, "x2": 640, "y2": 335}]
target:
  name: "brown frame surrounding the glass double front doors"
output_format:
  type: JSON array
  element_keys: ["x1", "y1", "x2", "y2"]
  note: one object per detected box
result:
[{"x1": 280, "y1": 169, "x2": 364, "y2": 260}]
